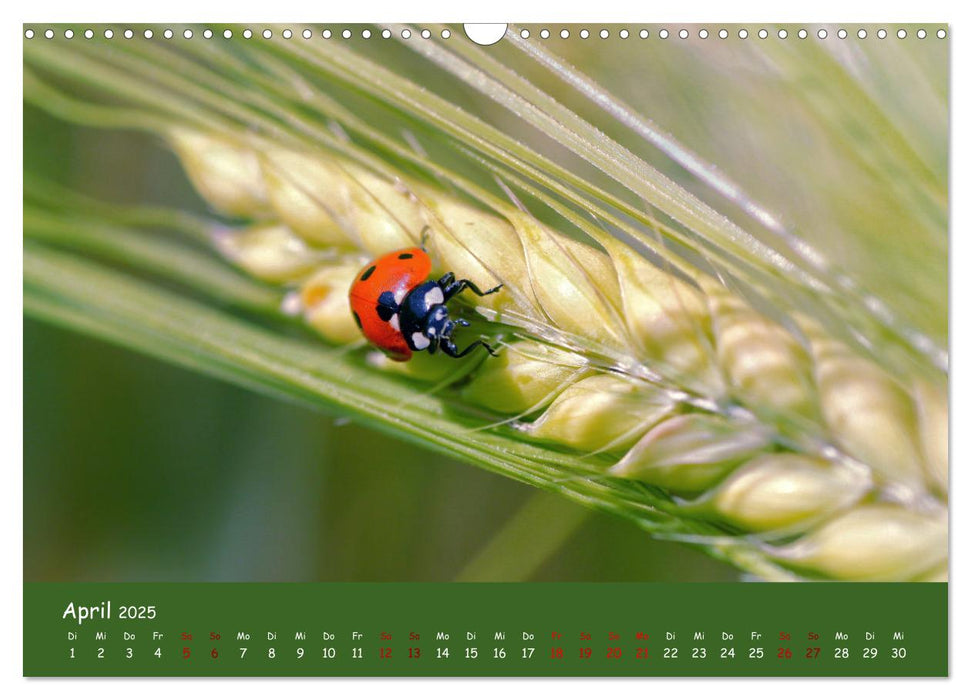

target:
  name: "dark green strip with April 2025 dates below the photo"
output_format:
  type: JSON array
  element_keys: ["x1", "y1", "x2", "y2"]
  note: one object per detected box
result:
[{"x1": 24, "y1": 583, "x2": 948, "y2": 677}]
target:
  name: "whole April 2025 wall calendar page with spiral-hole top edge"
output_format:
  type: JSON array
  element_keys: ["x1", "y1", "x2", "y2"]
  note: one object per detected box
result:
[{"x1": 22, "y1": 21, "x2": 950, "y2": 678}]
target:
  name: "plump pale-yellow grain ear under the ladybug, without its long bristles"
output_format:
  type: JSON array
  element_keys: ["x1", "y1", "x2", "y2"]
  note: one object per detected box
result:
[{"x1": 171, "y1": 131, "x2": 947, "y2": 580}]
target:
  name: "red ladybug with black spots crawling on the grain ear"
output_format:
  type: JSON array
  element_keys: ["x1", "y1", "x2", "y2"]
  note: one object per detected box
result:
[{"x1": 350, "y1": 248, "x2": 502, "y2": 362}]
